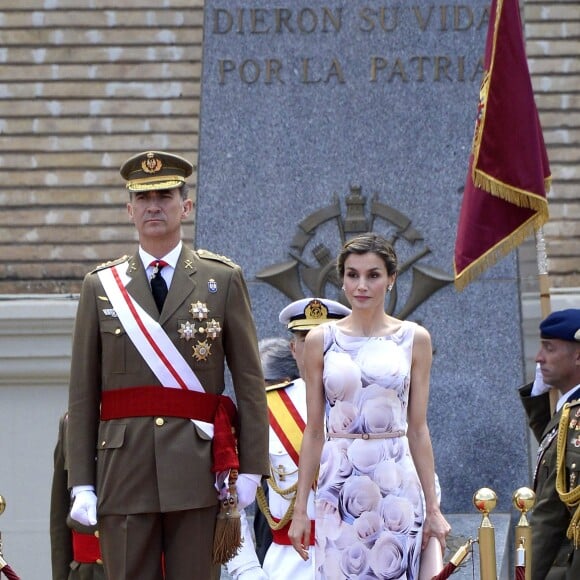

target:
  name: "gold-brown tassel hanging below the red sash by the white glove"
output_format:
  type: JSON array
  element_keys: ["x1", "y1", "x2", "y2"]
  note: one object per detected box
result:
[{"x1": 213, "y1": 469, "x2": 242, "y2": 564}]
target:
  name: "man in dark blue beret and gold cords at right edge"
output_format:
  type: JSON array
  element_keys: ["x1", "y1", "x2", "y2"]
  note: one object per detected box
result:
[{"x1": 519, "y1": 308, "x2": 580, "y2": 580}]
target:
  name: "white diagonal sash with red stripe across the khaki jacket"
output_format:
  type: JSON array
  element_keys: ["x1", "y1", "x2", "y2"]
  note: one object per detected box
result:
[{"x1": 98, "y1": 262, "x2": 213, "y2": 437}]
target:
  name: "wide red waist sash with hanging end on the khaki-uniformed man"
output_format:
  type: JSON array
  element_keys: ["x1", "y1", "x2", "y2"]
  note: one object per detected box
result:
[{"x1": 101, "y1": 386, "x2": 239, "y2": 473}]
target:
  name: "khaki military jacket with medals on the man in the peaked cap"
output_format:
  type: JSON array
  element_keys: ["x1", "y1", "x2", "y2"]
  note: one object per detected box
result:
[{"x1": 68, "y1": 246, "x2": 268, "y2": 515}]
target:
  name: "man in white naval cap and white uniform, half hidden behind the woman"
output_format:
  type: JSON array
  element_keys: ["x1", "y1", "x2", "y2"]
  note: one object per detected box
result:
[{"x1": 251, "y1": 298, "x2": 350, "y2": 580}]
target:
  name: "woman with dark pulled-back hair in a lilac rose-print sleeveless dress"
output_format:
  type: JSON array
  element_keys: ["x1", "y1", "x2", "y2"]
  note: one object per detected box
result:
[{"x1": 289, "y1": 234, "x2": 450, "y2": 580}]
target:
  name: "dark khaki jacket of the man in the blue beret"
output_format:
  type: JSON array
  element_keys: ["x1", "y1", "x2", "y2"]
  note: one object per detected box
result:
[{"x1": 519, "y1": 383, "x2": 580, "y2": 580}]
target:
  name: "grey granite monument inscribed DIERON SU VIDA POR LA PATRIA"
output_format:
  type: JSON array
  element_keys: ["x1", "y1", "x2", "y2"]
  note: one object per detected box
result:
[{"x1": 195, "y1": 0, "x2": 529, "y2": 513}]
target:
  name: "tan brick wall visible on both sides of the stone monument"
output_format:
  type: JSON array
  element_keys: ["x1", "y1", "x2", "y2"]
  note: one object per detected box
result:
[{"x1": 0, "y1": 0, "x2": 580, "y2": 294}]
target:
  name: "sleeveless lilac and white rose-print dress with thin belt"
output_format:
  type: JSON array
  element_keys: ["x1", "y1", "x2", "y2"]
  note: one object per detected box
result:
[{"x1": 315, "y1": 321, "x2": 424, "y2": 580}]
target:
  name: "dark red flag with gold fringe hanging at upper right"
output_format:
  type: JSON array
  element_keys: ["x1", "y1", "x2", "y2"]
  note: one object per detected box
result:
[{"x1": 454, "y1": 0, "x2": 551, "y2": 290}]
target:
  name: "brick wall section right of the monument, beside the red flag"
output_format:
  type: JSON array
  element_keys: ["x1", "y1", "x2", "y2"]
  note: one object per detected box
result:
[{"x1": 520, "y1": 0, "x2": 580, "y2": 290}]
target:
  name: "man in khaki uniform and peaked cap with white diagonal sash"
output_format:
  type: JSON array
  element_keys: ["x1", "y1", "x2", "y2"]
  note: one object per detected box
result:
[{"x1": 68, "y1": 151, "x2": 268, "y2": 580}]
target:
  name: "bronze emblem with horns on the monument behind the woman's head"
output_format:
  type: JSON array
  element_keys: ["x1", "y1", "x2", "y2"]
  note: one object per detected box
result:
[{"x1": 256, "y1": 186, "x2": 453, "y2": 319}]
